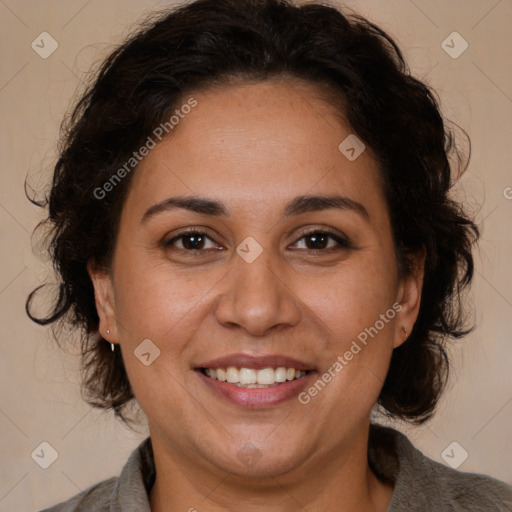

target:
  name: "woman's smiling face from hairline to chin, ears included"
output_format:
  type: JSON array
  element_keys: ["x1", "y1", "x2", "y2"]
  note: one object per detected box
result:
[{"x1": 90, "y1": 81, "x2": 420, "y2": 475}]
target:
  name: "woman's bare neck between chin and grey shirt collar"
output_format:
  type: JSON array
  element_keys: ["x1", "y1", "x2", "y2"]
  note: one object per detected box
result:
[{"x1": 150, "y1": 429, "x2": 393, "y2": 512}]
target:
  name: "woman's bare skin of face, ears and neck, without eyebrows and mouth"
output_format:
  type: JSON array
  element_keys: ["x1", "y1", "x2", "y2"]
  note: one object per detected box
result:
[{"x1": 89, "y1": 80, "x2": 422, "y2": 512}]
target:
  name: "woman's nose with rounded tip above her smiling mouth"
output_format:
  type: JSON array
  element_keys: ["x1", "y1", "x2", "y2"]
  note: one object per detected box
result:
[{"x1": 216, "y1": 247, "x2": 301, "y2": 336}]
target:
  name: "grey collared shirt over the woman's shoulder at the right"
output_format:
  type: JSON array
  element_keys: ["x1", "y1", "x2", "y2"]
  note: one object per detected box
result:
[{"x1": 370, "y1": 425, "x2": 512, "y2": 512}]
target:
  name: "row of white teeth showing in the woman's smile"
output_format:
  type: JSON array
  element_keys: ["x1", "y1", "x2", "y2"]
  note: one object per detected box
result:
[{"x1": 199, "y1": 366, "x2": 310, "y2": 388}]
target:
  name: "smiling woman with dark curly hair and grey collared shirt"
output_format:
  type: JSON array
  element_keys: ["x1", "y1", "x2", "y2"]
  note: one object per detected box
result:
[{"x1": 27, "y1": 0, "x2": 512, "y2": 512}]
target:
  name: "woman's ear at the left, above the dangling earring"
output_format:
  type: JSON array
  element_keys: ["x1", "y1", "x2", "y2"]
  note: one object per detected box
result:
[{"x1": 87, "y1": 263, "x2": 118, "y2": 343}]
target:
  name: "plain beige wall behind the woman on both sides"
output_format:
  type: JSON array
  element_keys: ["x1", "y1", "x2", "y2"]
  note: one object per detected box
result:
[{"x1": 0, "y1": 0, "x2": 512, "y2": 512}]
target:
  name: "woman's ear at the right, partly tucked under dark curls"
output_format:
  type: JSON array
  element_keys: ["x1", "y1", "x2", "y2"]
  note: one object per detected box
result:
[{"x1": 393, "y1": 248, "x2": 426, "y2": 348}]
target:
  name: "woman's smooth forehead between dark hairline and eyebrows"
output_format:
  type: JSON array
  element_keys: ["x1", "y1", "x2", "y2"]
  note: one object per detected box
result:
[{"x1": 123, "y1": 80, "x2": 383, "y2": 222}]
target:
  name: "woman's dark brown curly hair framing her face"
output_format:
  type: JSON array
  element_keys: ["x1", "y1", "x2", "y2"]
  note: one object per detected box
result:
[{"x1": 26, "y1": 0, "x2": 479, "y2": 423}]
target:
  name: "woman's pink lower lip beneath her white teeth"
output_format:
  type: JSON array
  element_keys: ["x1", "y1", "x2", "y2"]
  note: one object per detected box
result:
[{"x1": 196, "y1": 370, "x2": 315, "y2": 409}]
